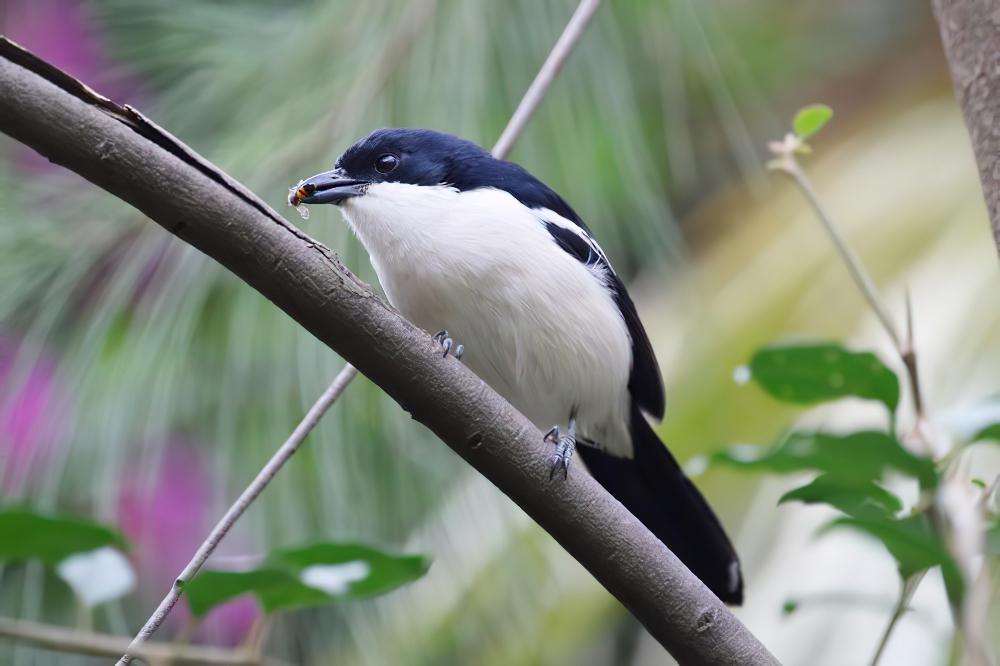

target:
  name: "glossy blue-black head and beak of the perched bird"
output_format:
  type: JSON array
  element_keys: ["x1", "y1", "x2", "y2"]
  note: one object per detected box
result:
[{"x1": 289, "y1": 128, "x2": 493, "y2": 206}]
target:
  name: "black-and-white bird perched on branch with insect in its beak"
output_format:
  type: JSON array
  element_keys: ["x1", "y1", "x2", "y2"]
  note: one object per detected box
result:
[{"x1": 289, "y1": 128, "x2": 743, "y2": 605}]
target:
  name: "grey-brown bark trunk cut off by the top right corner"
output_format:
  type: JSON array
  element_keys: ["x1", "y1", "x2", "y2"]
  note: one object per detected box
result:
[{"x1": 934, "y1": 0, "x2": 1000, "y2": 251}]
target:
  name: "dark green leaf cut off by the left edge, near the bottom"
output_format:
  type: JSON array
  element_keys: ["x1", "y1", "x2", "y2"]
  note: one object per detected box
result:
[{"x1": 0, "y1": 509, "x2": 128, "y2": 566}]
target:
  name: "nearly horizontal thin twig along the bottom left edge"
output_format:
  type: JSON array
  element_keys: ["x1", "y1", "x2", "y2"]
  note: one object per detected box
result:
[{"x1": 0, "y1": 618, "x2": 290, "y2": 666}]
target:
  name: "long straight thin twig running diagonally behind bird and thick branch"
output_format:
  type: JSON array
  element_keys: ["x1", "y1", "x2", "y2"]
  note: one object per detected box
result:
[{"x1": 118, "y1": 0, "x2": 600, "y2": 666}]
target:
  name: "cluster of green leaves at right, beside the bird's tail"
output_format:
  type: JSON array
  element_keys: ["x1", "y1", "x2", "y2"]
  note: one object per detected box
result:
[{"x1": 713, "y1": 343, "x2": 1000, "y2": 599}]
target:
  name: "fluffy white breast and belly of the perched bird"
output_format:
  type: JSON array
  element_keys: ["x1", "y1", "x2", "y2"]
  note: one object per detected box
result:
[{"x1": 341, "y1": 183, "x2": 632, "y2": 455}]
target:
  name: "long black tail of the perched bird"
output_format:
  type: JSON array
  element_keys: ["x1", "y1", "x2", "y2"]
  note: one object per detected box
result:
[{"x1": 577, "y1": 407, "x2": 743, "y2": 605}]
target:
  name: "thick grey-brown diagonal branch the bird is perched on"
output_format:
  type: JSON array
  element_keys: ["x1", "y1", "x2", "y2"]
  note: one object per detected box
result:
[{"x1": 0, "y1": 39, "x2": 777, "y2": 664}]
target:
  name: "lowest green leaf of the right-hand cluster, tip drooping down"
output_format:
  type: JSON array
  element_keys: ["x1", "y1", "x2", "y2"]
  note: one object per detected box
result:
[{"x1": 828, "y1": 515, "x2": 964, "y2": 602}]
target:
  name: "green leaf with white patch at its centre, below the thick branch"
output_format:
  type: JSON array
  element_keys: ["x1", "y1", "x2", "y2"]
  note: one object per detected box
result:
[{"x1": 184, "y1": 543, "x2": 429, "y2": 616}]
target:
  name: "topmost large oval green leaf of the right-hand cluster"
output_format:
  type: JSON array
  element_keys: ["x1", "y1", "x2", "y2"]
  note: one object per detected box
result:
[{"x1": 750, "y1": 343, "x2": 899, "y2": 412}]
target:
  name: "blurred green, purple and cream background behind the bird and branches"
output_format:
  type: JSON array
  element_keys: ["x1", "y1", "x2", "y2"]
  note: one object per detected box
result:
[{"x1": 0, "y1": 0, "x2": 1000, "y2": 666}]
